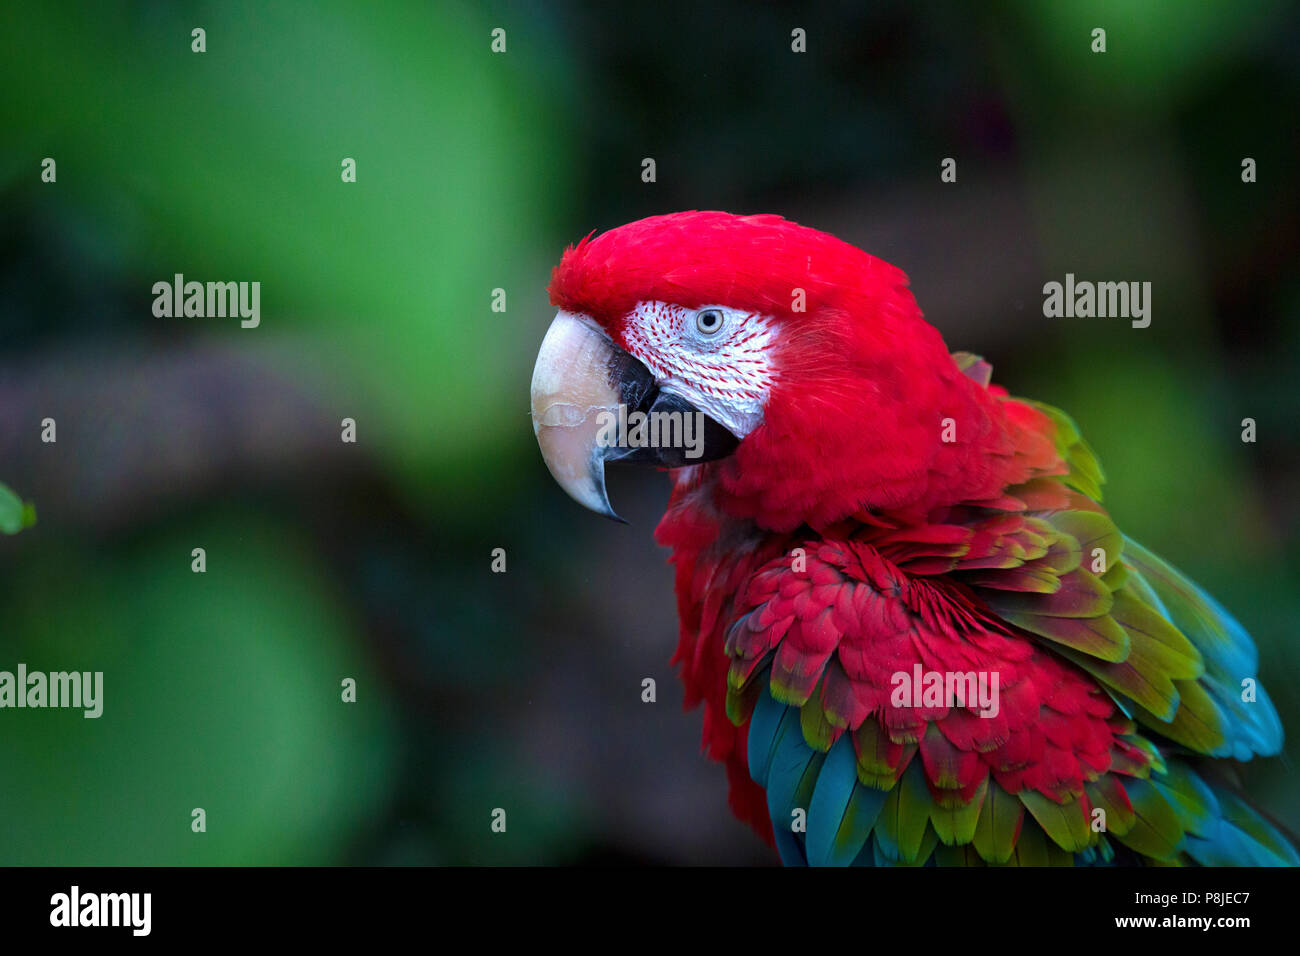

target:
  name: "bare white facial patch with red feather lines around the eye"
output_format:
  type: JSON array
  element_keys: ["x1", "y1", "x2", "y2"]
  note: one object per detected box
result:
[{"x1": 623, "y1": 302, "x2": 776, "y2": 438}]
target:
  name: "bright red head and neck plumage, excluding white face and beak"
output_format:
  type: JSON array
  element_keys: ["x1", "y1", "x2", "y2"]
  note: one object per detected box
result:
[{"x1": 550, "y1": 212, "x2": 1063, "y2": 531}]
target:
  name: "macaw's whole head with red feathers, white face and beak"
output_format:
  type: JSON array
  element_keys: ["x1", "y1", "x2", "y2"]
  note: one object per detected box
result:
[{"x1": 532, "y1": 212, "x2": 1024, "y2": 531}]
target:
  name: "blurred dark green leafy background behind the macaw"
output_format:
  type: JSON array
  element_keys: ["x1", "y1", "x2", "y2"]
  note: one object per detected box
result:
[{"x1": 0, "y1": 0, "x2": 1300, "y2": 864}]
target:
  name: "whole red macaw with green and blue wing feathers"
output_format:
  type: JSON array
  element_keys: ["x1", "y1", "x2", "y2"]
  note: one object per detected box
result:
[{"x1": 532, "y1": 212, "x2": 1300, "y2": 865}]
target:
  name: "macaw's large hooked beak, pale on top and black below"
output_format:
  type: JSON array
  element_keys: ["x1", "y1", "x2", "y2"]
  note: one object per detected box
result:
[{"x1": 532, "y1": 312, "x2": 737, "y2": 522}]
